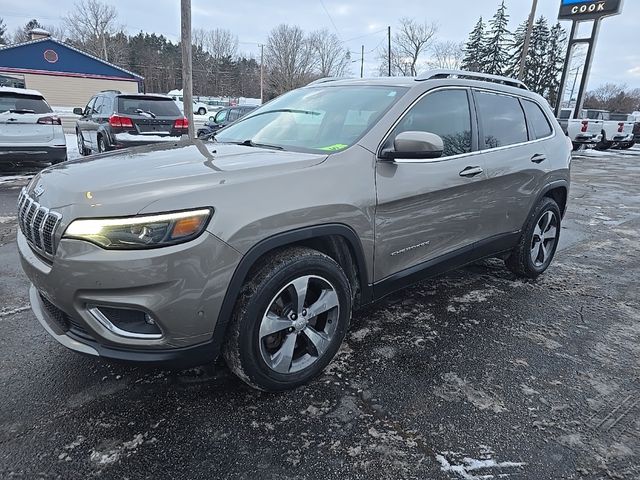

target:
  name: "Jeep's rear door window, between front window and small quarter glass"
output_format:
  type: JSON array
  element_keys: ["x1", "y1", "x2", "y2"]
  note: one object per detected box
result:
[{"x1": 476, "y1": 92, "x2": 528, "y2": 148}]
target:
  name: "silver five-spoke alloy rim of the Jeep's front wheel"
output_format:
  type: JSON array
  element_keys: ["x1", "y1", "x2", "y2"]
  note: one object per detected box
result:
[{"x1": 258, "y1": 275, "x2": 340, "y2": 374}]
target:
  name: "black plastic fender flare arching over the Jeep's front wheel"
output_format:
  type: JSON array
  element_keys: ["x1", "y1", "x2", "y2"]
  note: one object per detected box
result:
[{"x1": 212, "y1": 223, "x2": 373, "y2": 355}]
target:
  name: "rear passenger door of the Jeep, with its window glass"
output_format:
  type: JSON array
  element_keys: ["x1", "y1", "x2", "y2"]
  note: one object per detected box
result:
[{"x1": 473, "y1": 90, "x2": 553, "y2": 235}]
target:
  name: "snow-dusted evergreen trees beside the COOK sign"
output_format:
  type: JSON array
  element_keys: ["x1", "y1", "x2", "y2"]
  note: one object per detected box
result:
[{"x1": 462, "y1": 0, "x2": 567, "y2": 105}]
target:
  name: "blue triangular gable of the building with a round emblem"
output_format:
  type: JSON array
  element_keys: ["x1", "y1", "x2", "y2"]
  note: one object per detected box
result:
[{"x1": 0, "y1": 37, "x2": 143, "y2": 81}]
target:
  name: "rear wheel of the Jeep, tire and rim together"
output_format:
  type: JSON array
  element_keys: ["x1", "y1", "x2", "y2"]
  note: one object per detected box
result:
[{"x1": 505, "y1": 197, "x2": 562, "y2": 278}]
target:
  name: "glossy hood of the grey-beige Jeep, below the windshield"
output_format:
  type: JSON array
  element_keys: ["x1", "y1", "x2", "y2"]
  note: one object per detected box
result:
[{"x1": 28, "y1": 140, "x2": 327, "y2": 218}]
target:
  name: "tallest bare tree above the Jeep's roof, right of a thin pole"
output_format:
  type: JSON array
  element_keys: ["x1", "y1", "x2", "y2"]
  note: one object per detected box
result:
[{"x1": 379, "y1": 17, "x2": 438, "y2": 76}]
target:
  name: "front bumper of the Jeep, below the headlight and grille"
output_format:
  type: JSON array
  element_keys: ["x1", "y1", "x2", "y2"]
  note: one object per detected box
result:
[{"x1": 18, "y1": 232, "x2": 240, "y2": 366}]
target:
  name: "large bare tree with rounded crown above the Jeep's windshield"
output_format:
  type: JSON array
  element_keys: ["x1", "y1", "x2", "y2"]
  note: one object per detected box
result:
[{"x1": 265, "y1": 24, "x2": 316, "y2": 97}]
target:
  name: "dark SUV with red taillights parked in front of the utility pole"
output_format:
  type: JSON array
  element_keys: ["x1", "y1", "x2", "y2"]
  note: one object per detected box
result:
[{"x1": 73, "y1": 90, "x2": 189, "y2": 155}]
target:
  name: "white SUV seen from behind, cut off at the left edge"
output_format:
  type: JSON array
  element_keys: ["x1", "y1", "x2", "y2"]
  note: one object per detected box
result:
[{"x1": 0, "y1": 87, "x2": 67, "y2": 168}]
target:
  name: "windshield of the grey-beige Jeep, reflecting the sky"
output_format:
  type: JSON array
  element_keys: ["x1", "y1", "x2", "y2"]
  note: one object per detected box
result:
[{"x1": 216, "y1": 85, "x2": 406, "y2": 152}]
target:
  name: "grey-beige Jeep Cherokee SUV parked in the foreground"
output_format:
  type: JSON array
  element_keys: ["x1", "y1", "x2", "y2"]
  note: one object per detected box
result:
[{"x1": 18, "y1": 71, "x2": 571, "y2": 391}]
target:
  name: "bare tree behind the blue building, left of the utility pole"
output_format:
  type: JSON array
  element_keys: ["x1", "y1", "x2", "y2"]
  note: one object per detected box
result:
[{"x1": 63, "y1": 0, "x2": 122, "y2": 61}]
